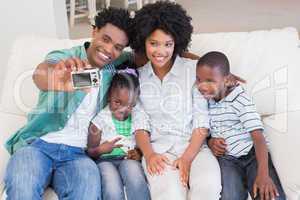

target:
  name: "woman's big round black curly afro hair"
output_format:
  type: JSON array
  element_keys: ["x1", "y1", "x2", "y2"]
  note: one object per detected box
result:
[{"x1": 129, "y1": 1, "x2": 193, "y2": 58}]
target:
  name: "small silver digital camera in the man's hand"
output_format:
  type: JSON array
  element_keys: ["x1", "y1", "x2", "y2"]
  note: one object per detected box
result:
[{"x1": 71, "y1": 68, "x2": 101, "y2": 89}]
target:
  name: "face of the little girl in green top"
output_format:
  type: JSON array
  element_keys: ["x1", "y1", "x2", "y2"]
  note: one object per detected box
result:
[{"x1": 108, "y1": 87, "x2": 136, "y2": 121}]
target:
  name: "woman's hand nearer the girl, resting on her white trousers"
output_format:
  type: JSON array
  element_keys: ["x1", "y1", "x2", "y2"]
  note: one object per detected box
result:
[{"x1": 145, "y1": 153, "x2": 170, "y2": 176}]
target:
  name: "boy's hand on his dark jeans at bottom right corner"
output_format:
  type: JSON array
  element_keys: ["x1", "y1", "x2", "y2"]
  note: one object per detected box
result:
[{"x1": 253, "y1": 175, "x2": 279, "y2": 200}]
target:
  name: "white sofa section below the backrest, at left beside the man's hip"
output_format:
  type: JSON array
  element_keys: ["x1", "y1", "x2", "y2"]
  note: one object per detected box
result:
[{"x1": 0, "y1": 112, "x2": 26, "y2": 184}]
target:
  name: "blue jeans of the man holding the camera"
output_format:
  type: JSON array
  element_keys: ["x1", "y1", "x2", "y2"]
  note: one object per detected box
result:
[{"x1": 5, "y1": 139, "x2": 101, "y2": 200}]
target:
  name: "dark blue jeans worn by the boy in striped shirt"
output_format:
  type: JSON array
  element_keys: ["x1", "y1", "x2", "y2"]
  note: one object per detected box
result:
[{"x1": 218, "y1": 148, "x2": 286, "y2": 200}]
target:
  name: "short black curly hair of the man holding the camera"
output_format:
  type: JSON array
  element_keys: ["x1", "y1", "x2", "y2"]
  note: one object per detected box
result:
[{"x1": 93, "y1": 7, "x2": 132, "y2": 38}]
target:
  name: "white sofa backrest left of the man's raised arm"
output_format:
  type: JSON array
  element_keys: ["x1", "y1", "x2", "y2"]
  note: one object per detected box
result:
[{"x1": 0, "y1": 35, "x2": 85, "y2": 115}]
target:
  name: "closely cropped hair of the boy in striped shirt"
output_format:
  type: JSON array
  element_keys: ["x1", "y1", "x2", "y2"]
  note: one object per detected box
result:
[{"x1": 197, "y1": 51, "x2": 230, "y2": 76}]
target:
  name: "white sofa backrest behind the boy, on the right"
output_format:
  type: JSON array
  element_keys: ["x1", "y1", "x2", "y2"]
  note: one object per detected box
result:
[{"x1": 191, "y1": 28, "x2": 299, "y2": 115}]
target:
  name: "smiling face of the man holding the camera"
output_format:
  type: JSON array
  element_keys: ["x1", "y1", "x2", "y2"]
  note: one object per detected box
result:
[{"x1": 87, "y1": 23, "x2": 128, "y2": 68}]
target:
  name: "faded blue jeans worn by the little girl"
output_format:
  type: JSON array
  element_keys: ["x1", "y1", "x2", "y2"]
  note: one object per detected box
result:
[{"x1": 98, "y1": 158, "x2": 150, "y2": 200}]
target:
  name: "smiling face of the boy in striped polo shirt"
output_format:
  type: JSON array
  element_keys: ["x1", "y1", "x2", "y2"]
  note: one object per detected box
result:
[{"x1": 196, "y1": 65, "x2": 227, "y2": 101}]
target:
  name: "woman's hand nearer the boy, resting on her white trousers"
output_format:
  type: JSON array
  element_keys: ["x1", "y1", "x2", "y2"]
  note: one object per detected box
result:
[{"x1": 173, "y1": 157, "x2": 192, "y2": 187}]
